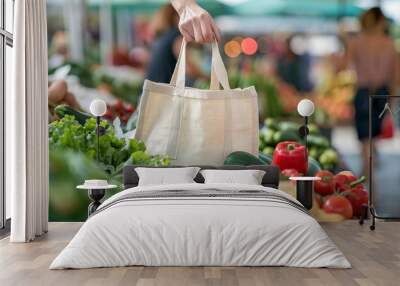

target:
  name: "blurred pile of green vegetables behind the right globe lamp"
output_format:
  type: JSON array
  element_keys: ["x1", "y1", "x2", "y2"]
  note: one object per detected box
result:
[{"x1": 260, "y1": 118, "x2": 339, "y2": 170}]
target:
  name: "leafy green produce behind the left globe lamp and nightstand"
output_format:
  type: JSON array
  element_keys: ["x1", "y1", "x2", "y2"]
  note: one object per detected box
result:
[{"x1": 49, "y1": 114, "x2": 169, "y2": 221}]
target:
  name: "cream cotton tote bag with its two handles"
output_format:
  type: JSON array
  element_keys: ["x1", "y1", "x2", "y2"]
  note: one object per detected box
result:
[{"x1": 135, "y1": 40, "x2": 258, "y2": 165}]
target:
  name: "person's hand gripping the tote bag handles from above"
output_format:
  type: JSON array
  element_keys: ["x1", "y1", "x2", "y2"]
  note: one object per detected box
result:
[{"x1": 173, "y1": 1, "x2": 221, "y2": 43}]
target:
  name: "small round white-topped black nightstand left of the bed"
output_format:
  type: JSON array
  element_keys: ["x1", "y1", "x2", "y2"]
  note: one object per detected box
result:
[{"x1": 76, "y1": 180, "x2": 117, "y2": 217}]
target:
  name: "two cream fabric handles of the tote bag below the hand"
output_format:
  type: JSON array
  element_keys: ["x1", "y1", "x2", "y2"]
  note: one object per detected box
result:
[{"x1": 170, "y1": 39, "x2": 230, "y2": 90}]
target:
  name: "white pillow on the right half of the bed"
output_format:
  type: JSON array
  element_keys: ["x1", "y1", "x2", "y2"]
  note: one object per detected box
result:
[{"x1": 200, "y1": 170, "x2": 265, "y2": 185}]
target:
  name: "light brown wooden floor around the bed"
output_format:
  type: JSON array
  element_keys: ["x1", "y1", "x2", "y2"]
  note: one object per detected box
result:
[{"x1": 0, "y1": 221, "x2": 400, "y2": 286}]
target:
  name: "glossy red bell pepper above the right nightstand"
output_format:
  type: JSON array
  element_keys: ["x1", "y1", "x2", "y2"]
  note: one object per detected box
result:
[{"x1": 272, "y1": 141, "x2": 308, "y2": 175}]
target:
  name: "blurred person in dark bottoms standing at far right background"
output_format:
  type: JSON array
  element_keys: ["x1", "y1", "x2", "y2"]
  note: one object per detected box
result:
[{"x1": 340, "y1": 7, "x2": 398, "y2": 175}]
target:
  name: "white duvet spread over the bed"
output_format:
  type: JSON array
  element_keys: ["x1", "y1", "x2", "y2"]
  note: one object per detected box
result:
[{"x1": 50, "y1": 184, "x2": 351, "y2": 269}]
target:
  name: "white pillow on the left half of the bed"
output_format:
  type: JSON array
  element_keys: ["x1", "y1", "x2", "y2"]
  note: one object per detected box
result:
[{"x1": 135, "y1": 167, "x2": 200, "y2": 186}]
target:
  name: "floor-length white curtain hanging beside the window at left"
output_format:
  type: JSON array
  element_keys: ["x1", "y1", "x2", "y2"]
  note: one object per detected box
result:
[{"x1": 6, "y1": 0, "x2": 49, "y2": 242}]
